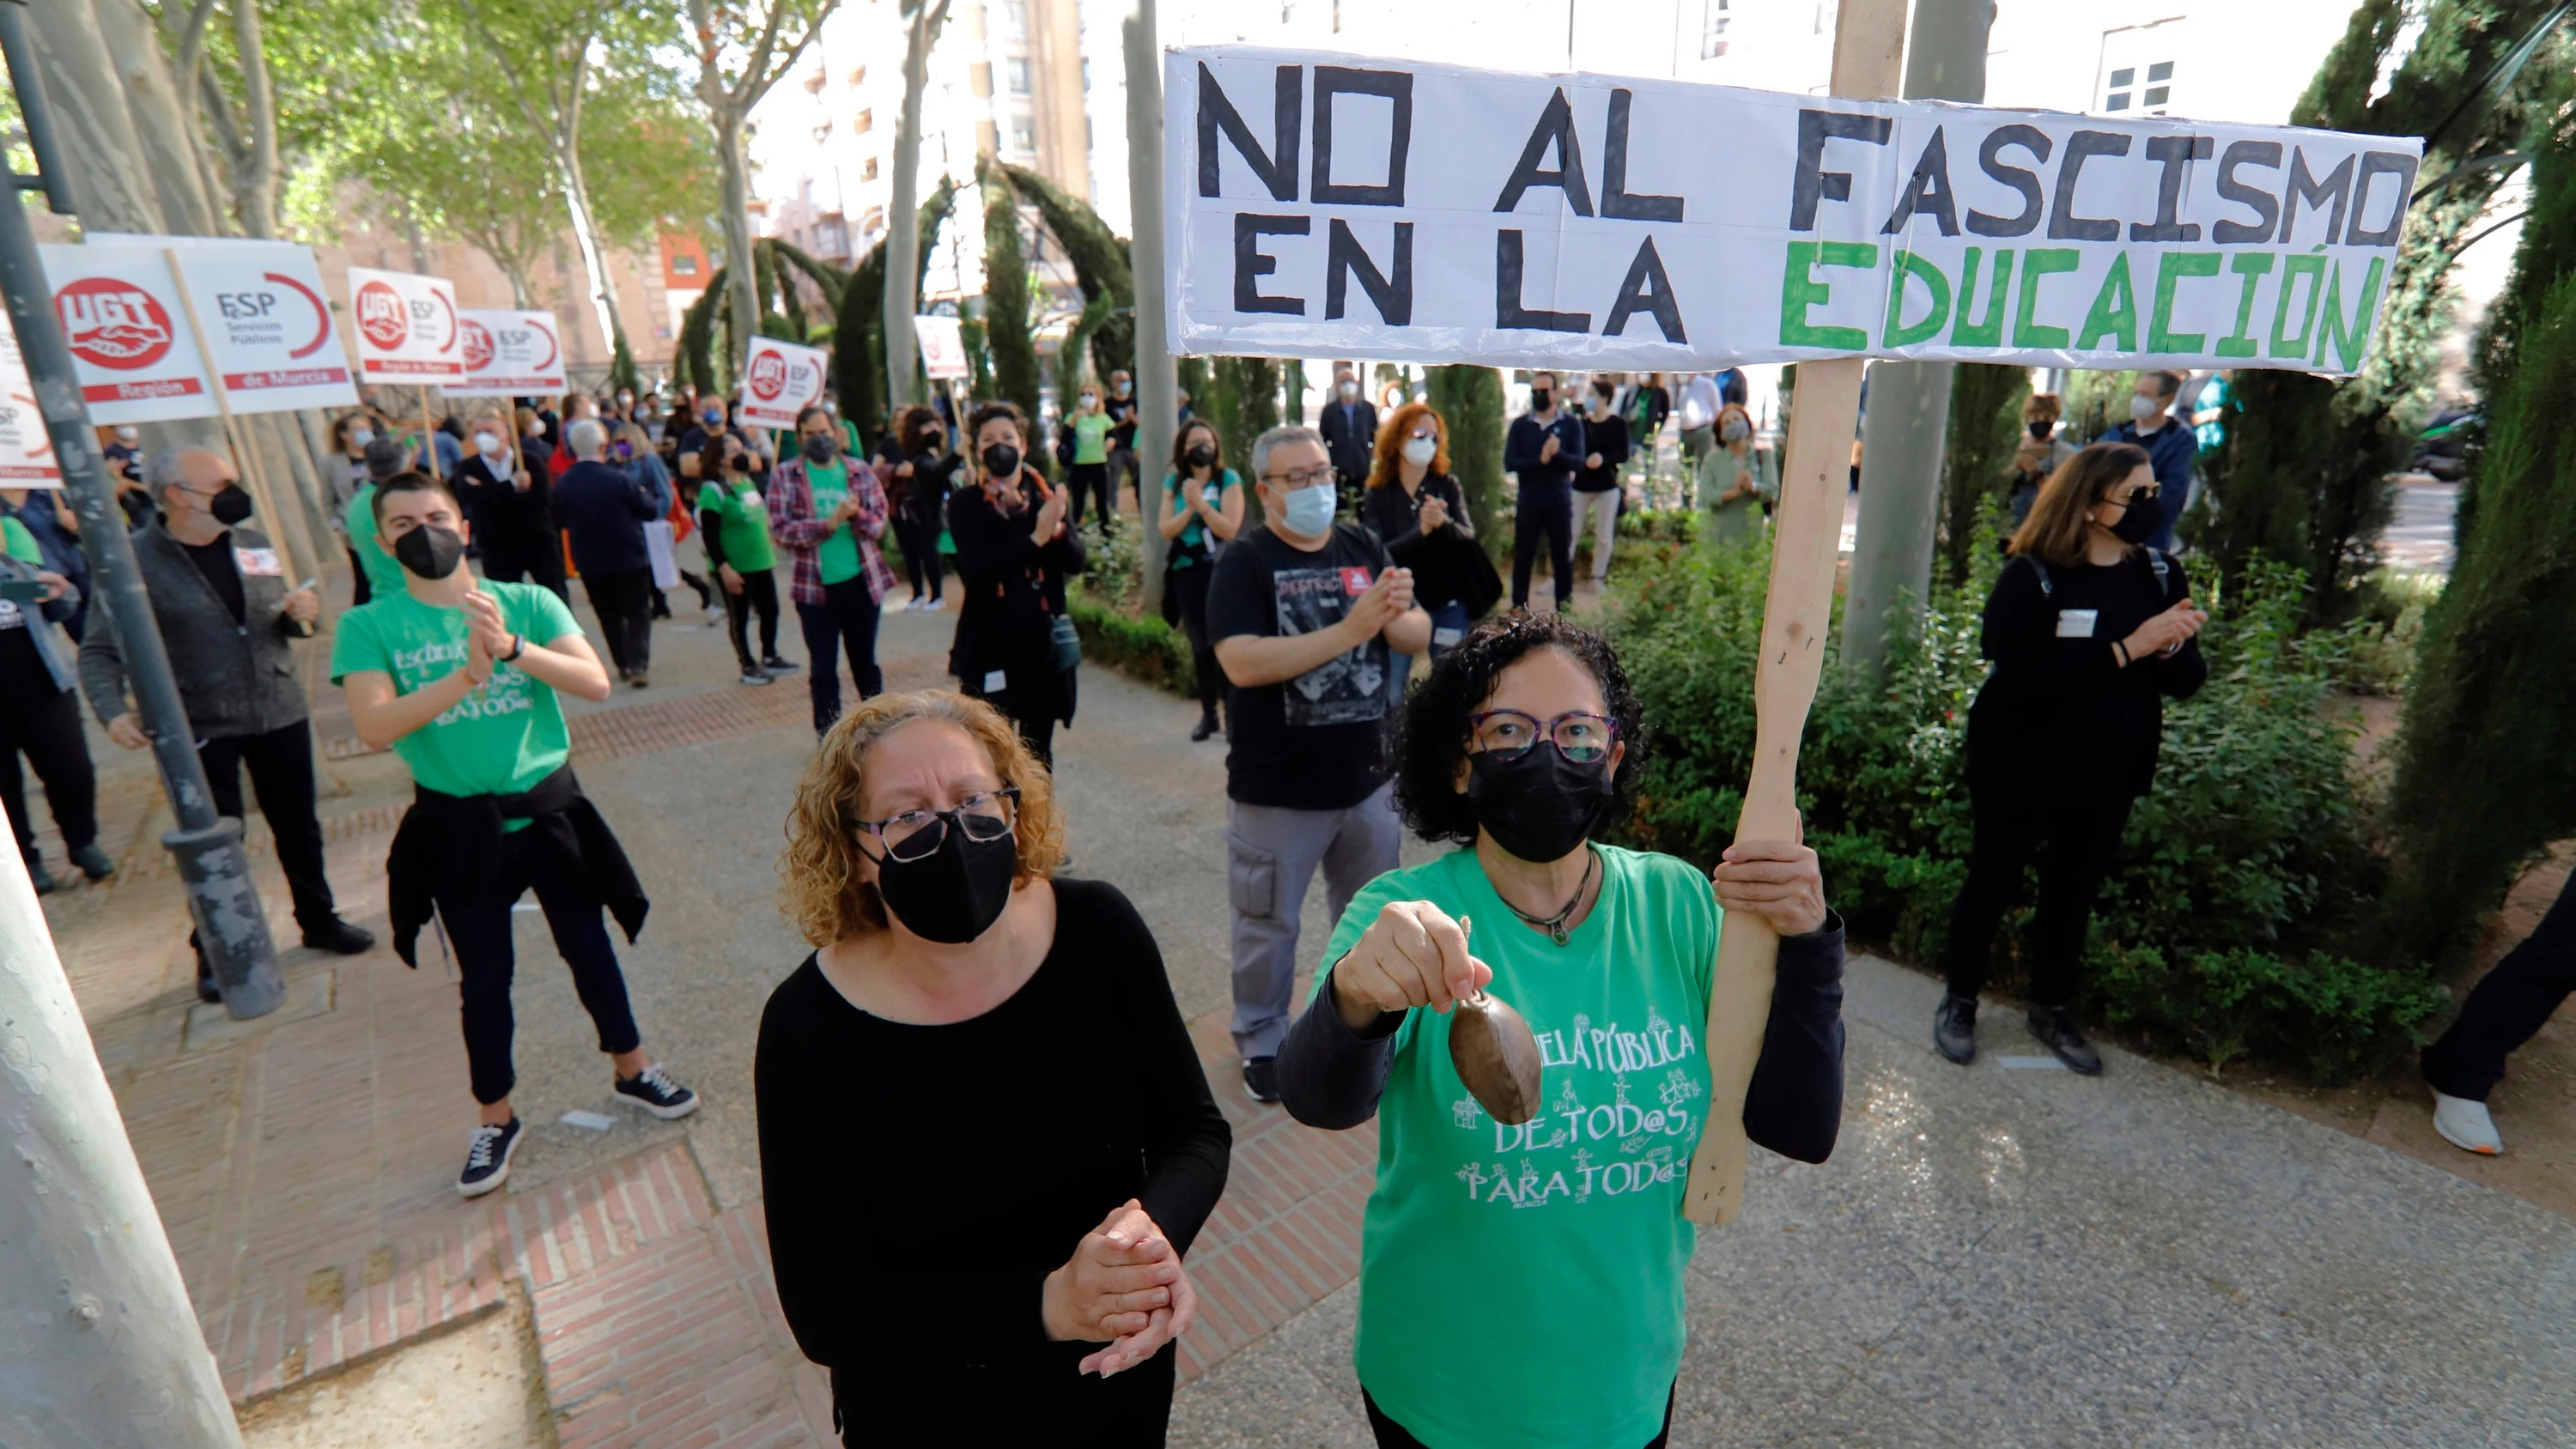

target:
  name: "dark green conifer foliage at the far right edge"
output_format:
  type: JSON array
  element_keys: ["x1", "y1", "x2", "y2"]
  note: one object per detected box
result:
[{"x1": 2380, "y1": 105, "x2": 2576, "y2": 965}]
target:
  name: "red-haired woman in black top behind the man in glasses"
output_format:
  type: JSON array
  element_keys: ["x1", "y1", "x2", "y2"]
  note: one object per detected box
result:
[{"x1": 1360, "y1": 402, "x2": 1502, "y2": 700}]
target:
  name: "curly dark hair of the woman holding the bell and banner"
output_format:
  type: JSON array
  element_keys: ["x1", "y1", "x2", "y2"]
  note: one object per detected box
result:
[{"x1": 1396, "y1": 613, "x2": 1646, "y2": 844}]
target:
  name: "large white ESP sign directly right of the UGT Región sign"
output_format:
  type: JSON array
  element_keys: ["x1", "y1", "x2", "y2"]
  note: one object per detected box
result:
[{"x1": 167, "y1": 237, "x2": 358, "y2": 412}]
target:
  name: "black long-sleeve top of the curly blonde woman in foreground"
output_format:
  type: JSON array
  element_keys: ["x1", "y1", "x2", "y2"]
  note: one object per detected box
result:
[{"x1": 752, "y1": 880, "x2": 1234, "y2": 1444}]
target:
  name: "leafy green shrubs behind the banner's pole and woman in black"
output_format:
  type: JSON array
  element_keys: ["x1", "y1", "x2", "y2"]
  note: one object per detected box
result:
[{"x1": 1610, "y1": 546, "x2": 2439, "y2": 1078}]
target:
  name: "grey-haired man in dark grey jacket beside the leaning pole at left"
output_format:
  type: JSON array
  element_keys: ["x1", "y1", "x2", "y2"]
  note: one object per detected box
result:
[{"x1": 80, "y1": 443, "x2": 386, "y2": 1001}]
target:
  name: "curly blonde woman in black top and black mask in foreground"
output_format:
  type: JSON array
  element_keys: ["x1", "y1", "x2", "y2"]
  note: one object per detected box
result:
[{"x1": 752, "y1": 690, "x2": 1231, "y2": 1446}]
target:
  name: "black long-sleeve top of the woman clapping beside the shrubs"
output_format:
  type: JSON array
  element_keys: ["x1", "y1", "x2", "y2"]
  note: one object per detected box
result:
[{"x1": 1968, "y1": 549, "x2": 2210, "y2": 800}]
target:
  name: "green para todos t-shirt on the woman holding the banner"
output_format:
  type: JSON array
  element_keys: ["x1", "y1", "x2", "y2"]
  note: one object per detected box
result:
[{"x1": 1309, "y1": 846, "x2": 1718, "y2": 1449}]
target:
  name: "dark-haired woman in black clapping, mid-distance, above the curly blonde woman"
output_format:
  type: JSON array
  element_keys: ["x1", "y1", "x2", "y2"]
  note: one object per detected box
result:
[{"x1": 948, "y1": 402, "x2": 1082, "y2": 764}]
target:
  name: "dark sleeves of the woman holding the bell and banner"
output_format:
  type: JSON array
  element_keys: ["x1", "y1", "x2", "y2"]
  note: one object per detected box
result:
[{"x1": 1278, "y1": 911, "x2": 1842, "y2": 1163}]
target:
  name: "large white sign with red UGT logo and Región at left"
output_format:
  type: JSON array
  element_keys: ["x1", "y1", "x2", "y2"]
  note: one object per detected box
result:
[{"x1": 39, "y1": 245, "x2": 216, "y2": 425}]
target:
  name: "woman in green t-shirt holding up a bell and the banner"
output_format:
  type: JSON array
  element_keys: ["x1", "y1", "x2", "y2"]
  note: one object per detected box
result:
[{"x1": 1278, "y1": 615, "x2": 1842, "y2": 1449}]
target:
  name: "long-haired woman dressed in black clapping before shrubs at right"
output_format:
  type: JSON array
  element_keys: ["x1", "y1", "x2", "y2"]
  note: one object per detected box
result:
[{"x1": 1932, "y1": 443, "x2": 2210, "y2": 1076}]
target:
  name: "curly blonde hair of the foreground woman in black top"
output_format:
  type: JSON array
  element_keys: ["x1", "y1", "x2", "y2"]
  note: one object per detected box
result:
[{"x1": 778, "y1": 690, "x2": 1064, "y2": 947}]
